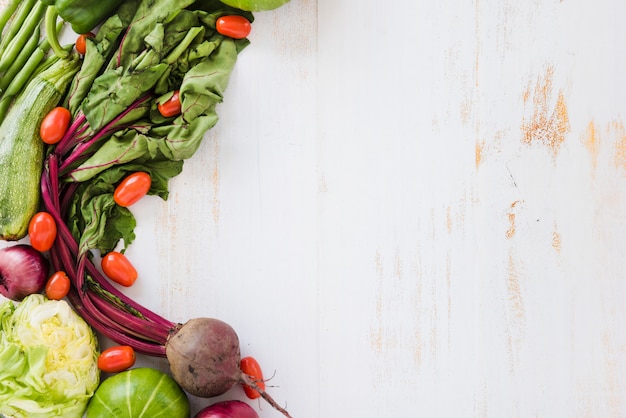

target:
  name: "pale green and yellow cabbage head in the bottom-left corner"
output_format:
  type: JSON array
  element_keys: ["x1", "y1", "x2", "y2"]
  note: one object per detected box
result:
[{"x1": 0, "y1": 294, "x2": 100, "y2": 418}]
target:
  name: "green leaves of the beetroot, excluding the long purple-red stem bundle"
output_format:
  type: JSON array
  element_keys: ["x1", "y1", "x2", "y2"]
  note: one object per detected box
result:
[{"x1": 64, "y1": 0, "x2": 253, "y2": 254}]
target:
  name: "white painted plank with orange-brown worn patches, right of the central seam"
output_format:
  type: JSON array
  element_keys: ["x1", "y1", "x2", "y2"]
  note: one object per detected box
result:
[{"x1": 319, "y1": 1, "x2": 626, "y2": 416}]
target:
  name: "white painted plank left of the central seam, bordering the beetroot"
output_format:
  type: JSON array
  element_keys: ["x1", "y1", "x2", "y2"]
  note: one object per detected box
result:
[{"x1": 149, "y1": 2, "x2": 318, "y2": 417}]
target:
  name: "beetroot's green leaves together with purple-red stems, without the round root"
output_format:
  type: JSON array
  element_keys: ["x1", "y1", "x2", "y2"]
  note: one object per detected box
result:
[{"x1": 41, "y1": 0, "x2": 253, "y2": 362}]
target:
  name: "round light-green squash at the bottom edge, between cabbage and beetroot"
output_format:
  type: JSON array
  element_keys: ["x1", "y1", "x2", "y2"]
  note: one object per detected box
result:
[{"x1": 86, "y1": 367, "x2": 190, "y2": 418}]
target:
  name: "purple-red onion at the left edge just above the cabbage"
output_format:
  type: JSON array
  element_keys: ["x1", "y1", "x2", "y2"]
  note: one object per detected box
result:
[{"x1": 0, "y1": 244, "x2": 50, "y2": 302}]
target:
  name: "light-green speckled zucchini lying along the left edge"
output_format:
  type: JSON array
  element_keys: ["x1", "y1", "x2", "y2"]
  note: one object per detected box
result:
[{"x1": 0, "y1": 54, "x2": 80, "y2": 241}]
